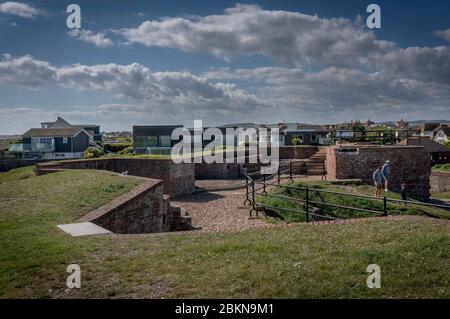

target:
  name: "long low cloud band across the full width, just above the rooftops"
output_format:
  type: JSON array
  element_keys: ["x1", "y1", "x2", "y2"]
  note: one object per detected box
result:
[{"x1": 0, "y1": 56, "x2": 450, "y2": 129}]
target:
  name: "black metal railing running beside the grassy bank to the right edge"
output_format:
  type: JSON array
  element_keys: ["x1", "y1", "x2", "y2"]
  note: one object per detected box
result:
[{"x1": 244, "y1": 168, "x2": 450, "y2": 222}]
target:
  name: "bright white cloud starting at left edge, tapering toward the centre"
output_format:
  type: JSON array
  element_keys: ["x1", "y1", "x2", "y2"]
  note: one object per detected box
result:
[{"x1": 0, "y1": 55, "x2": 265, "y2": 114}]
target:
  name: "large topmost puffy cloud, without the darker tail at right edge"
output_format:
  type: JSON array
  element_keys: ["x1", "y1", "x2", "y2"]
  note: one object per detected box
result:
[{"x1": 120, "y1": 5, "x2": 394, "y2": 65}]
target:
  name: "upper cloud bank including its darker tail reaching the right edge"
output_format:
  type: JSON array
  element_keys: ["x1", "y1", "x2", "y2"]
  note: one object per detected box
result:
[{"x1": 119, "y1": 5, "x2": 450, "y2": 83}]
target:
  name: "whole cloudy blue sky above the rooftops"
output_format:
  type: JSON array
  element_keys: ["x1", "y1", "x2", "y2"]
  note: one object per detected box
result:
[{"x1": 0, "y1": 0, "x2": 450, "y2": 134}]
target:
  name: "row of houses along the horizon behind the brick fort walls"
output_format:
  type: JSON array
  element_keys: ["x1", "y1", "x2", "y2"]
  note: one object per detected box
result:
[{"x1": 9, "y1": 117, "x2": 450, "y2": 160}]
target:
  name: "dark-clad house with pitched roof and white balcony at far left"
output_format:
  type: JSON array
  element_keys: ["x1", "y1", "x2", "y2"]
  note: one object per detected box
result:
[{"x1": 9, "y1": 127, "x2": 90, "y2": 159}]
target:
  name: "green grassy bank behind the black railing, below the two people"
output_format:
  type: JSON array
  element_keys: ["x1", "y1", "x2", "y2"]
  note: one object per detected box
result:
[{"x1": 257, "y1": 182, "x2": 450, "y2": 222}]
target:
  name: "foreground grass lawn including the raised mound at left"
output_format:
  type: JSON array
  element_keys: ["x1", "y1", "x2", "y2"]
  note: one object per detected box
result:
[{"x1": 0, "y1": 168, "x2": 450, "y2": 298}]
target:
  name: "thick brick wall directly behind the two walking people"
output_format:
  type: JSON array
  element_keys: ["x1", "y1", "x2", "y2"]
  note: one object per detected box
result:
[{"x1": 326, "y1": 145, "x2": 431, "y2": 200}]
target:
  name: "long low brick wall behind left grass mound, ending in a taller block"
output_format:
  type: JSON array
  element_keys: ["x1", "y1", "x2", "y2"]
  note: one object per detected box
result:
[{"x1": 37, "y1": 158, "x2": 195, "y2": 197}]
